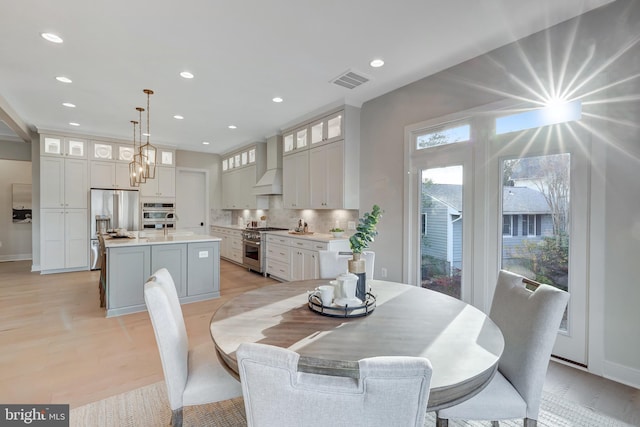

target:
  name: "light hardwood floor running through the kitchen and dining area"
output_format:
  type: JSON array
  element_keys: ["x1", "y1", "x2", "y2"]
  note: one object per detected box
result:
[{"x1": 0, "y1": 261, "x2": 640, "y2": 426}]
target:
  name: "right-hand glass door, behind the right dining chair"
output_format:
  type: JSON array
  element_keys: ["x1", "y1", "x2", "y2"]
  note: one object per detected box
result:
[{"x1": 494, "y1": 126, "x2": 589, "y2": 366}]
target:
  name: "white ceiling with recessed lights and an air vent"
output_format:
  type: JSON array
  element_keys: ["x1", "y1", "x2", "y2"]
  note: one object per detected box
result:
[{"x1": 0, "y1": 0, "x2": 610, "y2": 153}]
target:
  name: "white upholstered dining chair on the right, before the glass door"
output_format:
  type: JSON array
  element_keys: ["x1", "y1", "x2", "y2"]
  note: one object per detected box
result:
[{"x1": 436, "y1": 270, "x2": 569, "y2": 427}]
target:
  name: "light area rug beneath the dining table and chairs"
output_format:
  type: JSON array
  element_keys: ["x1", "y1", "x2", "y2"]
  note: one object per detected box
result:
[{"x1": 70, "y1": 382, "x2": 633, "y2": 427}]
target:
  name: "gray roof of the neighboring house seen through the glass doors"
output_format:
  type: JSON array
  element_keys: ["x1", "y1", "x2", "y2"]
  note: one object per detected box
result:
[{"x1": 423, "y1": 184, "x2": 551, "y2": 215}]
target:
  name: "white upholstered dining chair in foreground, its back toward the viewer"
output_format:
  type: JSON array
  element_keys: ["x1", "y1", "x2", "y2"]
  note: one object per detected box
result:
[{"x1": 236, "y1": 343, "x2": 432, "y2": 427}]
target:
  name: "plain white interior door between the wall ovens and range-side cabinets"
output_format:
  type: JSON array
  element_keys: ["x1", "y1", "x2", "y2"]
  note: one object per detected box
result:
[{"x1": 176, "y1": 168, "x2": 209, "y2": 235}]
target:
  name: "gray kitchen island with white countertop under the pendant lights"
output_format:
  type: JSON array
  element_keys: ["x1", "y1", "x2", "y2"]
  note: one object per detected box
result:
[{"x1": 102, "y1": 231, "x2": 221, "y2": 317}]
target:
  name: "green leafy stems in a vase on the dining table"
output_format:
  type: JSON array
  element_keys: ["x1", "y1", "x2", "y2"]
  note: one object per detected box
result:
[{"x1": 349, "y1": 205, "x2": 382, "y2": 301}]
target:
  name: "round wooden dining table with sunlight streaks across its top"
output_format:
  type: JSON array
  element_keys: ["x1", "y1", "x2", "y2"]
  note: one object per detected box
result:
[{"x1": 210, "y1": 279, "x2": 504, "y2": 411}]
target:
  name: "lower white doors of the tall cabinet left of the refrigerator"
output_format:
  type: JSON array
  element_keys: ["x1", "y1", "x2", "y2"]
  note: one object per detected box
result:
[{"x1": 40, "y1": 208, "x2": 89, "y2": 272}]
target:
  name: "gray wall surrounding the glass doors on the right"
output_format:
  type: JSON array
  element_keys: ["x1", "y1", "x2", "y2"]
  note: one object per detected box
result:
[{"x1": 360, "y1": 0, "x2": 640, "y2": 386}]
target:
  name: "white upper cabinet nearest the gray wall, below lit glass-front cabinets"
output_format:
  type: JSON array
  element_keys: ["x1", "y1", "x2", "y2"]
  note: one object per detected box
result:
[{"x1": 309, "y1": 141, "x2": 344, "y2": 209}]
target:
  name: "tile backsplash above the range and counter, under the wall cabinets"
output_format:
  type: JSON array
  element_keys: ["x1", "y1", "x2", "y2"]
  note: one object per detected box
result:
[{"x1": 210, "y1": 196, "x2": 358, "y2": 234}]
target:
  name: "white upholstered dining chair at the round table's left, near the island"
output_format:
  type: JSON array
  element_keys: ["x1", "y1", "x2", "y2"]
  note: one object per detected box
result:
[{"x1": 144, "y1": 268, "x2": 242, "y2": 426}]
